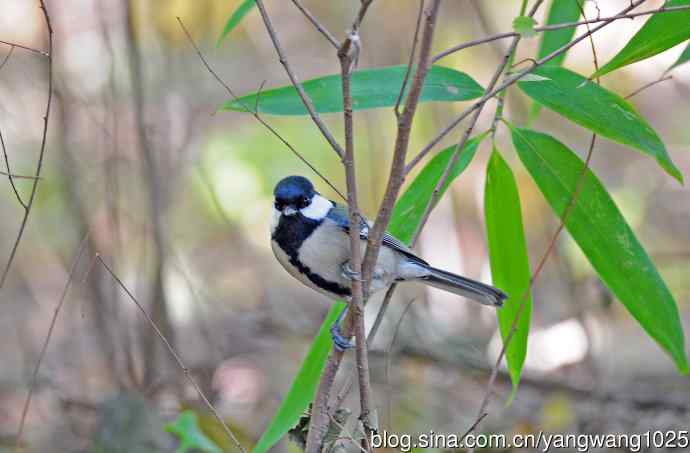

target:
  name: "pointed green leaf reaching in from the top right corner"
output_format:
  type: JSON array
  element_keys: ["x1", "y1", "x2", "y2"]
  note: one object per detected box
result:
[{"x1": 592, "y1": 0, "x2": 690, "y2": 77}]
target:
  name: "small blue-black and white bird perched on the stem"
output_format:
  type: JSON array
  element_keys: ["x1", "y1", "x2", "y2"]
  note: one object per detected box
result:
[{"x1": 271, "y1": 176, "x2": 508, "y2": 350}]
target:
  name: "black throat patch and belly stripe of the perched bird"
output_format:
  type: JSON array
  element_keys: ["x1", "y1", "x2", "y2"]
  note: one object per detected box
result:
[{"x1": 272, "y1": 213, "x2": 350, "y2": 296}]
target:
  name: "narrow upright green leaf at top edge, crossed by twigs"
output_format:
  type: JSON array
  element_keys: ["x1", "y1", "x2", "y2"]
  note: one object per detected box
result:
[{"x1": 528, "y1": 0, "x2": 582, "y2": 124}]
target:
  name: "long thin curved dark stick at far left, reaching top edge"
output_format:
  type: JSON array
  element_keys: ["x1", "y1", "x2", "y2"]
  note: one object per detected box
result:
[{"x1": 0, "y1": 0, "x2": 53, "y2": 289}]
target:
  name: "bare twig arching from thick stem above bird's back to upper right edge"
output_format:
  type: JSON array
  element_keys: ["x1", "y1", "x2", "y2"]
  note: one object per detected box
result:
[{"x1": 405, "y1": 0, "x2": 645, "y2": 174}]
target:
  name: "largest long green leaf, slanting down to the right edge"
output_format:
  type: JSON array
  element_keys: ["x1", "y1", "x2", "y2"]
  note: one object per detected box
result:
[{"x1": 512, "y1": 128, "x2": 688, "y2": 374}]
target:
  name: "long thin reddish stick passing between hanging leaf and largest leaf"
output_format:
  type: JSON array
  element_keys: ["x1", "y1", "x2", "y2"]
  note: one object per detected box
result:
[{"x1": 465, "y1": 7, "x2": 599, "y2": 444}]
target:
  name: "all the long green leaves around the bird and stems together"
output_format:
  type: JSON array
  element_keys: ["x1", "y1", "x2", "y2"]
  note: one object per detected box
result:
[{"x1": 199, "y1": 0, "x2": 690, "y2": 452}]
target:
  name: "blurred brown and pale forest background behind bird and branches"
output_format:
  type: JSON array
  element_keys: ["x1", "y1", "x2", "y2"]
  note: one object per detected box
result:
[{"x1": 0, "y1": 0, "x2": 690, "y2": 452}]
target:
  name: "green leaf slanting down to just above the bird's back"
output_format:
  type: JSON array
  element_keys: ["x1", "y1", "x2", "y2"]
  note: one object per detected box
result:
[{"x1": 388, "y1": 132, "x2": 487, "y2": 244}]
